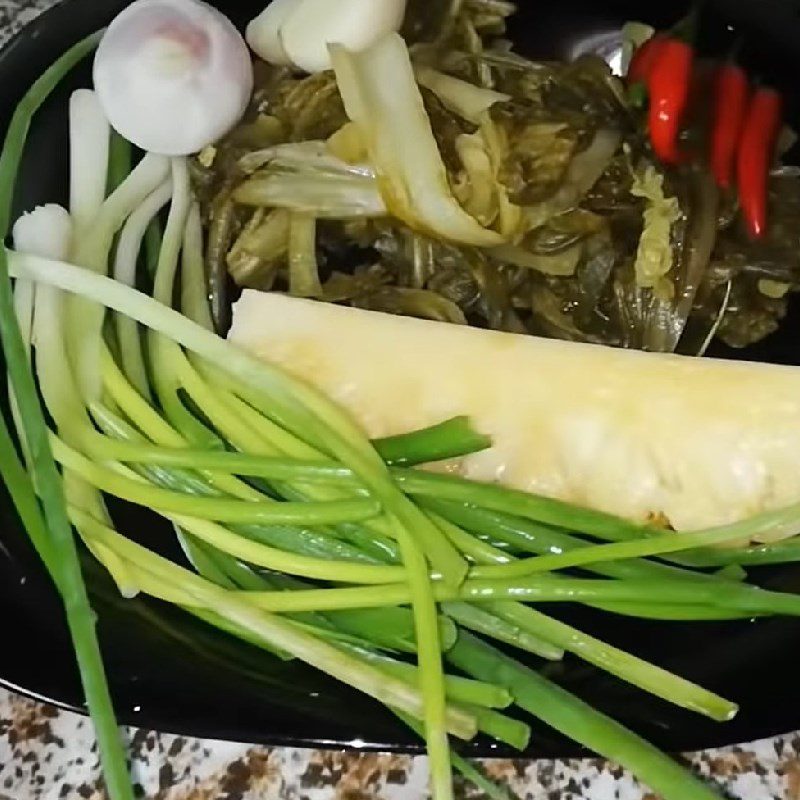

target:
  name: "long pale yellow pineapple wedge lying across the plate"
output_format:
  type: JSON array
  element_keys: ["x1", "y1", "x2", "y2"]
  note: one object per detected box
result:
[{"x1": 230, "y1": 291, "x2": 800, "y2": 530}]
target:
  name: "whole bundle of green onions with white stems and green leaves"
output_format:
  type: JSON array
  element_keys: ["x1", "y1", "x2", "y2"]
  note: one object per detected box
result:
[{"x1": 7, "y1": 26, "x2": 800, "y2": 800}]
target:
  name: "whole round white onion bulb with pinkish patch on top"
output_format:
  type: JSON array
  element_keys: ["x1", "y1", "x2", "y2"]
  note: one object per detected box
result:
[{"x1": 94, "y1": 0, "x2": 253, "y2": 156}]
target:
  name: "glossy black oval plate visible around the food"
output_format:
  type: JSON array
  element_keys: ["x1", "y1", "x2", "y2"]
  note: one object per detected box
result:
[{"x1": 0, "y1": 0, "x2": 800, "y2": 757}]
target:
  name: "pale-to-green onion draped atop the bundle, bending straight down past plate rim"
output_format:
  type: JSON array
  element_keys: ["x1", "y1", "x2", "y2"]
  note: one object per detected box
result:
[{"x1": 10, "y1": 248, "x2": 466, "y2": 800}]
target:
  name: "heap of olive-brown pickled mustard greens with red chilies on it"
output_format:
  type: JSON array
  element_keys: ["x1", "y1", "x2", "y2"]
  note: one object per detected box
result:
[{"x1": 192, "y1": 2, "x2": 800, "y2": 355}]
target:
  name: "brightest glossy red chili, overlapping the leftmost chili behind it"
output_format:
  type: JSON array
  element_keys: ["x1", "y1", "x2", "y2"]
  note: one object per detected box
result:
[{"x1": 649, "y1": 38, "x2": 694, "y2": 164}]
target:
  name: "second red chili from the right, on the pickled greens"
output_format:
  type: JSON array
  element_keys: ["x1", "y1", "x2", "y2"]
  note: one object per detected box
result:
[{"x1": 711, "y1": 62, "x2": 750, "y2": 189}]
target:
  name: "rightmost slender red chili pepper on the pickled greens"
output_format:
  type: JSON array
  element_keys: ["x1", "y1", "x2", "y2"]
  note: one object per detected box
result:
[{"x1": 737, "y1": 87, "x2": 783, "y2": 239}]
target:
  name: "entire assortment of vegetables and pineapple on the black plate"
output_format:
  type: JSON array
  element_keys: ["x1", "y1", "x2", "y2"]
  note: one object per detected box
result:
[{"x1": 0, "y1": 0, "x2": 800, "y2": 800}]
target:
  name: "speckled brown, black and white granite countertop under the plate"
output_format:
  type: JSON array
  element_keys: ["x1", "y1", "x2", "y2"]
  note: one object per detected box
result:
[{"x1": 0, "y1": 0, "x2": 800, "y2": 800}]
